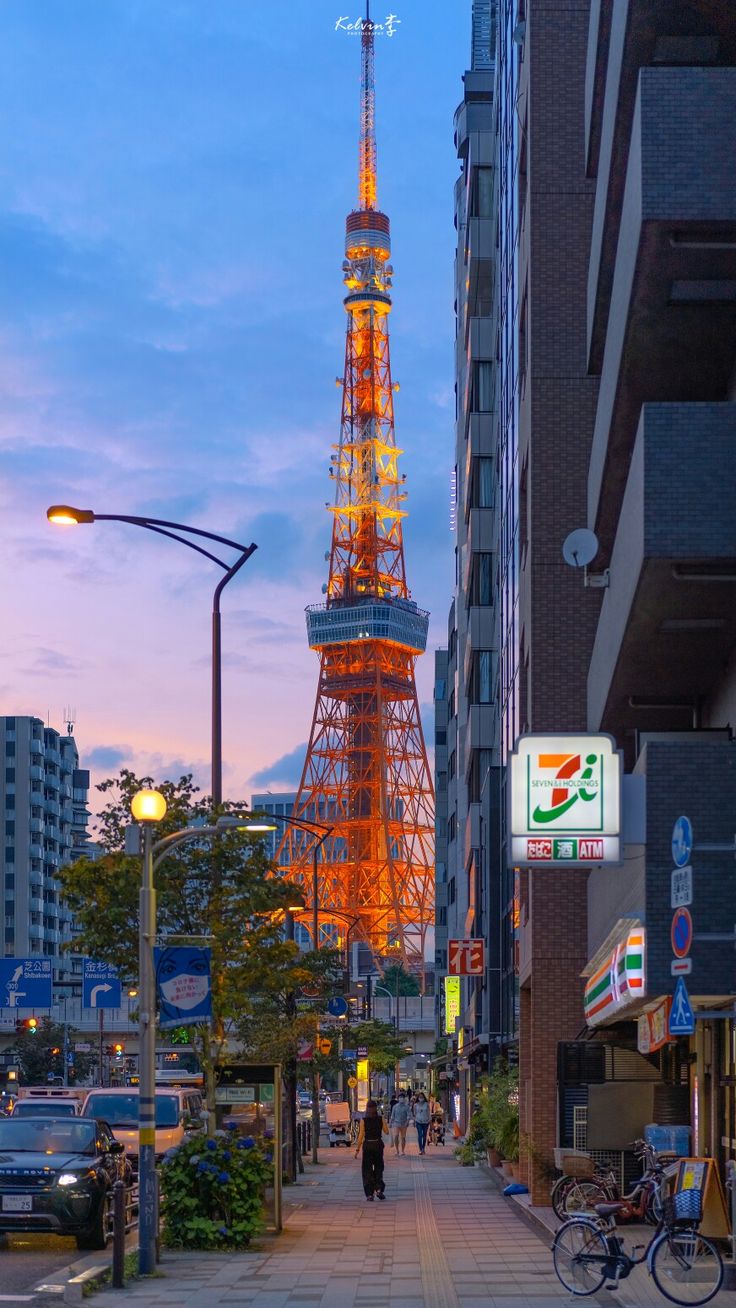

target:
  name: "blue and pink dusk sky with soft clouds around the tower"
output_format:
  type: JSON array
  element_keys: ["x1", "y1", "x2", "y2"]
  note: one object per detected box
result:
[{"x1": 0, "y1": 0, "x2": 471, "y2": 807}]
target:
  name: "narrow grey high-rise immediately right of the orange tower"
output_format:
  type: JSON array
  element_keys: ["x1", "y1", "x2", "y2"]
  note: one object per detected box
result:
[{"x1": 435, "y1": 0, "x2": 498, "y2": 1124}]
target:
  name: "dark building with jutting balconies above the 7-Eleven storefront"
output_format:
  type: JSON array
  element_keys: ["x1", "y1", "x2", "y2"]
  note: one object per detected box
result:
[{"x1": 575, "y1": 0, "x2": 736, "y2": 1182}]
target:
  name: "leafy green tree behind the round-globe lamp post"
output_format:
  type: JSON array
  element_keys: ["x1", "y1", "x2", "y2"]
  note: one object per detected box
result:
[{"x1": 60, "y1": 769, "x2": 298, "y2": 1129}]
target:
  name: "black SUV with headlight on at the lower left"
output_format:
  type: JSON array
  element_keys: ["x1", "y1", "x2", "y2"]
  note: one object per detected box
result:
[{"x1": 0, "y1": 1117, "x2": 131, "y2": 1249}]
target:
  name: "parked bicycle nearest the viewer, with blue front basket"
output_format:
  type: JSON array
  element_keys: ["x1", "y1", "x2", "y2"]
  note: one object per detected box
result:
[{"x1": 552, "y1": 1190, "x2": 723, "y2": 1305}]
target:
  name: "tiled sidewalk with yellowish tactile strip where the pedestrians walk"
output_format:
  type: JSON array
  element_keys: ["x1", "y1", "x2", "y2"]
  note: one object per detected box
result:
[{"x1": 84, "y1": 1145, "x2": 736, "y2": 1308}]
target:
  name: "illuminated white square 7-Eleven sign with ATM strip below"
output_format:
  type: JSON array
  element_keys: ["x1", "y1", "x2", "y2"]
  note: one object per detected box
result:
[{"x1": 509, "y1": 732, "x2": 621, "y2": 867}]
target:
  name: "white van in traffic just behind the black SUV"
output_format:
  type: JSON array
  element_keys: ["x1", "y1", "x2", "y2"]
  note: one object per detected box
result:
[{"x1": 82, "y1": 1086, "x2": 204, "y2": 1167}]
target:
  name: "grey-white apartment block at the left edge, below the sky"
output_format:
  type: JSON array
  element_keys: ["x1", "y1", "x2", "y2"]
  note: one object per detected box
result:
[{"x1": 0, "y1": 717, "x2": 89, "y2": 974}]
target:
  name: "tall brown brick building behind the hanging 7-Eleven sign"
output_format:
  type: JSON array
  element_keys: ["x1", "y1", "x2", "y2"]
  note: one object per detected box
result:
[{"x1": 493, "y1": 0, "x2": 600, "y2": 1202}]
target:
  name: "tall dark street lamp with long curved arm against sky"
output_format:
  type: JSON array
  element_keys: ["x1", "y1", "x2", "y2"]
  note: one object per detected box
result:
[{"x1": 46, "y1": 504, "x2": 258, "y2": 812}]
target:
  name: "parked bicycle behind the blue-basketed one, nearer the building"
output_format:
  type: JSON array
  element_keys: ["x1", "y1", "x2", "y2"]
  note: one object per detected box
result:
[{"x1": 550, "y1": 1141, "x2": 664, "y2": 1226}]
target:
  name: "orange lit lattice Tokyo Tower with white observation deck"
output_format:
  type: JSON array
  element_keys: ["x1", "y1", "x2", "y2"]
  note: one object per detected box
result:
[{"x1": 278, "y1": 10, "x2": 434, "y2": 969}]
